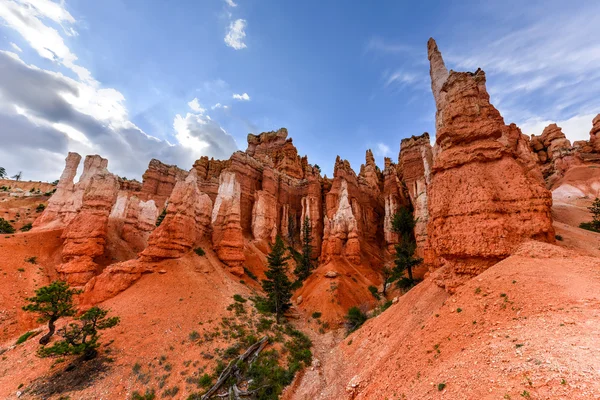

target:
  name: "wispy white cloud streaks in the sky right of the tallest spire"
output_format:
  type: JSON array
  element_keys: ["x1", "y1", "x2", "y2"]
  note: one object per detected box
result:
[{"x1": 441, "y1": 2, "x2": 600, "y2": 141}]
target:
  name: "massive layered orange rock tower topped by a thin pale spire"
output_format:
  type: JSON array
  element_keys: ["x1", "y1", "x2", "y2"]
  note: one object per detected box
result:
[{"x1": 427, "y1": 39, "x2": 554, "y2": 289}]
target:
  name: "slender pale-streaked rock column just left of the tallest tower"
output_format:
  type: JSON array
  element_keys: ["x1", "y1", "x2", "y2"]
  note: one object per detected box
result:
[{"x1": 398, "y1": 133, "x2": 433, "y2": 256}]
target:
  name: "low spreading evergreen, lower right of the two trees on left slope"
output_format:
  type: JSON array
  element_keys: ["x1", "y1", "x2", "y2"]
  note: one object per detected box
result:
[{"x1": 38, "y1": 307, "x2": 119, "y2": 360}]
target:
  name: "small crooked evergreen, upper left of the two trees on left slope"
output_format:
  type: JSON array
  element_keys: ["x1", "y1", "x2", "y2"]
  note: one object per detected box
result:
[{"x1": 23, "y1": 281, "x2": 81, "y2": 344}]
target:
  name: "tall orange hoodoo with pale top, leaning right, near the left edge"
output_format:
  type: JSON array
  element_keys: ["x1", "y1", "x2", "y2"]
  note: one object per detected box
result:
[{"x1": 56, "y1": 167, "x2": 119, "y2": 286}]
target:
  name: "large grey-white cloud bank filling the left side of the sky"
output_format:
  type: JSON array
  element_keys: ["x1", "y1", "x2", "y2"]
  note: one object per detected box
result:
[{"x1": 0, "y1": 0, "x2": 237, "y2": 180}]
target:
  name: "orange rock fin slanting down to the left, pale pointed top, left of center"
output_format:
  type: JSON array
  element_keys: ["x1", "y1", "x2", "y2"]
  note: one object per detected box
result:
[{"x1": 140, "y1": 169, "x2": 212, "y2": 261}]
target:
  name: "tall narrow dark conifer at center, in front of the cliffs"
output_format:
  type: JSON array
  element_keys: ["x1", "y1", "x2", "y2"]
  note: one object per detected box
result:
[{"x1": 262, "y1": 235, "x2": 292, "y2": 324}]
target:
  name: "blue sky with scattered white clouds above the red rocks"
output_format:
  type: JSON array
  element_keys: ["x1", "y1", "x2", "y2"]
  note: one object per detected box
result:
[{"x1": 0, "y1": 0, "x2": 600, "y2": 180}]
